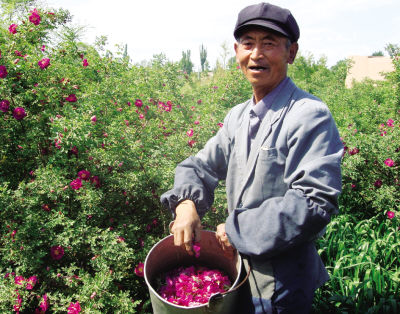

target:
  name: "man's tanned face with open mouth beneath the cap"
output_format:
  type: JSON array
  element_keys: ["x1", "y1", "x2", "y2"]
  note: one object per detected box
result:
[{"x1": 235, "y1": 28, "x2": 298, "y2": 102}]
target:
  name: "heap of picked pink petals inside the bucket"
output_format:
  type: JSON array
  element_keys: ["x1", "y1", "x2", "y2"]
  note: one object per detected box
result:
[{"x1": 158, "y1": 266, "x2": 231, "y2": 307}]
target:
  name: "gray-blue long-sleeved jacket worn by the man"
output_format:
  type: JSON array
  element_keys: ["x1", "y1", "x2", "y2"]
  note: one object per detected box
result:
[{"x1": 161, "y1": 80, "x2": 343, "y2": 306}]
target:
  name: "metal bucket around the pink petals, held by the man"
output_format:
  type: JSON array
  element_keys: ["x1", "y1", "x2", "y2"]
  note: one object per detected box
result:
[{"x1": 144, "y1": 230, "x2": 247, "y2": 314}]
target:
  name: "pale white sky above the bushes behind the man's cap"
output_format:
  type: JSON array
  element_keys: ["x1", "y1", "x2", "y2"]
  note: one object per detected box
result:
[{"x1": 43, "y1": 0, "x2": 400, "y2": 70}]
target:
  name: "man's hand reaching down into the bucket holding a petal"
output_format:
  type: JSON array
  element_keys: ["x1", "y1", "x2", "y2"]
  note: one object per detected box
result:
[{"x1": 171, "y1": 200, "x2": 201, "y2": 255}]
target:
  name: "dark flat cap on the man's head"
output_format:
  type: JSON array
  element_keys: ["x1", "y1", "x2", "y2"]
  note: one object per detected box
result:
[{"x1": 233, "y1": 2, "x2": 300, "y2": 42}]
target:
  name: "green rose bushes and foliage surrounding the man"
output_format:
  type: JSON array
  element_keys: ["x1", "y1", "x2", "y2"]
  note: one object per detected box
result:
[{"x1": 0, "y1": 1, "x2": 400, "y2": 313}]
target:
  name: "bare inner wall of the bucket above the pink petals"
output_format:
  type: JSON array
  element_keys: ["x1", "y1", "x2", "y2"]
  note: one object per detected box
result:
[{"x1": 144, "y1": 230, "x2": 242, "y2": 299}]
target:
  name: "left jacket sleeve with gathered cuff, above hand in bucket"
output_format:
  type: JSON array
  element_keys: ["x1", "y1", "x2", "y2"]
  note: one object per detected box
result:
[{"x1": 161, "y1": 111, "x2": 232, "y2": 218}]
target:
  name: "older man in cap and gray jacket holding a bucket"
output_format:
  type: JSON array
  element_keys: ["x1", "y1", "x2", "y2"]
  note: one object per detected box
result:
[{"x1": 161, "y1": 3, "x2": 343, "y2": 313}]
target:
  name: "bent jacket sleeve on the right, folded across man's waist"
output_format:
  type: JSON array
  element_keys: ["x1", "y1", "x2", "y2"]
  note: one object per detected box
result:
[{"x1": 226, "y1": 103, "x2": 343, "y2": 258}]
